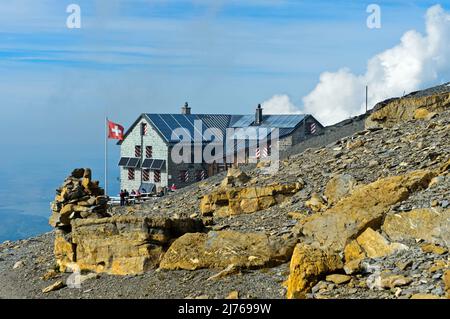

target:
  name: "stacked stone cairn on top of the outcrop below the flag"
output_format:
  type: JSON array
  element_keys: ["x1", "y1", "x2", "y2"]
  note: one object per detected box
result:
[{"x1": 49, "y1": 168, "x2": 109, "y2": 231}]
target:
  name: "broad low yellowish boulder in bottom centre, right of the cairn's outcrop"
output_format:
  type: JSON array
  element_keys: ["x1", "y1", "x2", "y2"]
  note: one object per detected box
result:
[{"x1": 160, "y1": 231, "x2": 296, "y2": 270}]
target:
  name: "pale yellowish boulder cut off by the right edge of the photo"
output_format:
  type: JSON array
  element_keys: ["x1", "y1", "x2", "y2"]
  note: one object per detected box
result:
[{"x1": 382, "y1": 208, "x2": 450, "y2": 247}]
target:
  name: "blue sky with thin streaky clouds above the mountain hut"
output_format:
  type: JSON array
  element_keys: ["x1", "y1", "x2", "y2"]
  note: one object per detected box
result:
[{"x1": 0, "y1": 0, "x2": 448, "y2": 145}]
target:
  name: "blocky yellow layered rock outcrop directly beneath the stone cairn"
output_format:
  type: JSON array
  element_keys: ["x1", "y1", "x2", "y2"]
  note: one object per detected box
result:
[{"x1": 55, "y1": 216, "x2": 203, "y2": 275}]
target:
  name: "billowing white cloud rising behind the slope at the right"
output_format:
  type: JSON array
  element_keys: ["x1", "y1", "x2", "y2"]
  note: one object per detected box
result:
[{"x1": 303, "y1": 5, "x2": 450, "y2": 124}]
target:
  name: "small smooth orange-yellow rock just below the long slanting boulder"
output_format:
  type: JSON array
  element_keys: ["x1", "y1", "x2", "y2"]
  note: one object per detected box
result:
[{"x1": 356, "y1": 228, "x2": 407, "y2": 258}]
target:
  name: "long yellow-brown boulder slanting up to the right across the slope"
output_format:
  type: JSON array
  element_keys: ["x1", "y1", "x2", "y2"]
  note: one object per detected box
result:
[{"x1": 293, "y1": 170, "x2": 433, "y2": 251}]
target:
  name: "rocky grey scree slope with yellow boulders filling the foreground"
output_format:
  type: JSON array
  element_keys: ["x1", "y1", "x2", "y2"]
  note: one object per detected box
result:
[{"x1": 0, "y1": 85, "x2": 450, "y2": 299}]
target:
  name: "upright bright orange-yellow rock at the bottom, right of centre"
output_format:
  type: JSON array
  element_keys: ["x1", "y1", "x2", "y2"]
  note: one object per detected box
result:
[{"x1": 287, "y1": 243, "x2": 343, "y2": 299}]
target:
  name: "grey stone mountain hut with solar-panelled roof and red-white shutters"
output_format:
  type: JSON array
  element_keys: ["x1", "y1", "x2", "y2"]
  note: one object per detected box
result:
[{"x1": 118, "y1": 103, "x2": 324, "y2": 191}]
